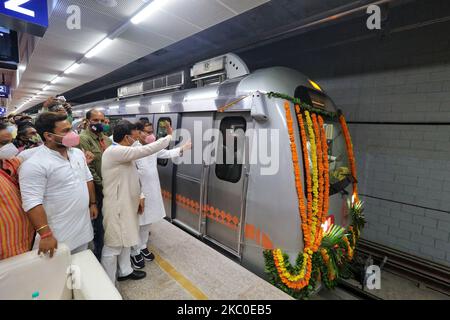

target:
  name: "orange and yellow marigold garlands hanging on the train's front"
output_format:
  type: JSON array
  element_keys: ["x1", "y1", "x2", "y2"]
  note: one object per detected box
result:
[{"x1": 264, "y1": 97, "x2": 359, "y2": 294}]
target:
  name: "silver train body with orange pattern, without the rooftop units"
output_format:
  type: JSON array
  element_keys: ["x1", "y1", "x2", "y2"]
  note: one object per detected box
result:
[{"x1": 74, "y1": 67, "x2": 351, "y2": 277}]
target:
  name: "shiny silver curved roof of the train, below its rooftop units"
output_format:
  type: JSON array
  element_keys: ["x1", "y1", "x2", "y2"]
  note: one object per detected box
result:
[{"x1": 73, "y1": 67, "x2": 317, "y2": 117}]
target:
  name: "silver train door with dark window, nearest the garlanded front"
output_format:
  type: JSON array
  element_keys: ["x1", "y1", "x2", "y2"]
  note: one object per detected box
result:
[{"x1": 204, "y1": 113, "x2": 253, "y2": 256}]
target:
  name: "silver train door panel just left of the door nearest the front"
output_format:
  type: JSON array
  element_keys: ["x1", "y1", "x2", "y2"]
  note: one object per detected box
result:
[{"x1": 173, "y1": 112, "x2": 213, "y2": 235}]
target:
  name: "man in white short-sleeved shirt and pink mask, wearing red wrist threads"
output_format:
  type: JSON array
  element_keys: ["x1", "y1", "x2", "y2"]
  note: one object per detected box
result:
[{"x1": 19, "y1": 112, "x2": 98, "y2": 257}]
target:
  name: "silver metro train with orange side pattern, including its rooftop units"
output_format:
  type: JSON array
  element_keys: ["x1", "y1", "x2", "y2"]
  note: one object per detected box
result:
[{"x1": 73, "y1": 54, "x2": 352, "y2": 278}]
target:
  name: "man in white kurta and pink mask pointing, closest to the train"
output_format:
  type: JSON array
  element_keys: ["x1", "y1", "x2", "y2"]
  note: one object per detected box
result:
[{"x1": 131, "y1": 122, "x2": 191, "y2": 269}]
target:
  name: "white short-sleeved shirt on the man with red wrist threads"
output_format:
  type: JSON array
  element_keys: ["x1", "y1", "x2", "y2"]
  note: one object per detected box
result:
[{"x1": 20, "y1": 146, "x2": 94, "y2": 253}]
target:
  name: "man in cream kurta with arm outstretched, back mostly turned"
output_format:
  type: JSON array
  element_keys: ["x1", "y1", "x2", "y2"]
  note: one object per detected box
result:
[{"x1": 102, "y1": 121, "x2": 172, "y2": 282}]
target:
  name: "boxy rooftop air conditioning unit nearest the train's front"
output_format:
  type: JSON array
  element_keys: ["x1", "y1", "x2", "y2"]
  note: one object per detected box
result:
[{"x1": 191, "y1": 53, "x2": 250, "y2": 87}]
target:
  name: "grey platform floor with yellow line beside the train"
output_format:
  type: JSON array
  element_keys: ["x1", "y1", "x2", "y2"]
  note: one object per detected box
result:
[{"x1": 118, "y1": 220, "x2": 292, "y2": 300}]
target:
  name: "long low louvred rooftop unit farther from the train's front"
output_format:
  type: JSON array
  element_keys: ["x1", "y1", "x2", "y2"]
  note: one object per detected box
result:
[{"x1": 117, "y1": 71, "x2": 184, "y2": 99}]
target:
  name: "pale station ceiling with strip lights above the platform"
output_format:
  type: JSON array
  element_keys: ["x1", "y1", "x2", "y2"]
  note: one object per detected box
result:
[{"x1": 3, "y1": 0, "x2": 268, "y2": 112}]
